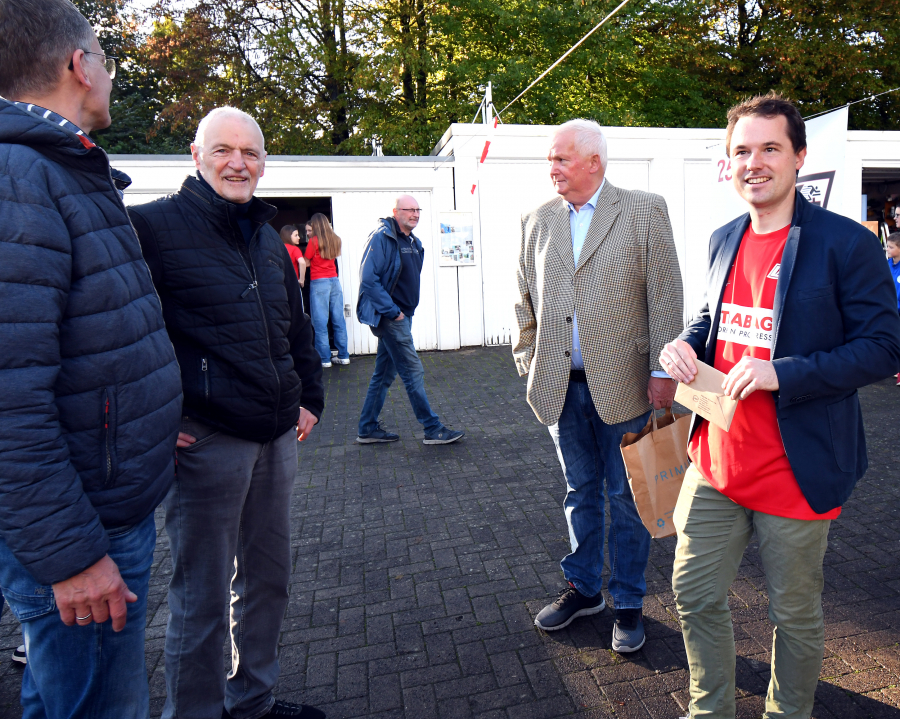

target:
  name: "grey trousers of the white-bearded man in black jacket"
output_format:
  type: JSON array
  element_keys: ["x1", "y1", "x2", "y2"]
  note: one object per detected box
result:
[{"x1": 163, "y1": 418, "x2": 297, "y2": 719}]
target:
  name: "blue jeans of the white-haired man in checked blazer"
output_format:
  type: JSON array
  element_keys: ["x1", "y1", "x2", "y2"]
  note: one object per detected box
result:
[{"x1": 550, "y1": 382, "x2": 650, "y2": 609}]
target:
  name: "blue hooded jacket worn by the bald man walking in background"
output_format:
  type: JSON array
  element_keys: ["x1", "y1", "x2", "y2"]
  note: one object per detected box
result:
[{"x1": 356, "y1": 217, "x2": 425, "y2": 327}]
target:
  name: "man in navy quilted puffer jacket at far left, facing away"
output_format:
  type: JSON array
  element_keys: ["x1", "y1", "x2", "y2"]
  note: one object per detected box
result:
[{"x1": 0, "y1": 0, "x2": 181, "y2": 719}]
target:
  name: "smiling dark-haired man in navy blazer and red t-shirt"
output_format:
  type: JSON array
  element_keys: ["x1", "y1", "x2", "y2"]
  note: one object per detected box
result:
[{"x1": 660, "y1": 93, "x2": 900, "y2": 719}]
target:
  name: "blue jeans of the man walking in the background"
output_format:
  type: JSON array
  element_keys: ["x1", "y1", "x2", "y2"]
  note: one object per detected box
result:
[{"x1": 359, "y1": 317, "x2": 442, "y2": 437}]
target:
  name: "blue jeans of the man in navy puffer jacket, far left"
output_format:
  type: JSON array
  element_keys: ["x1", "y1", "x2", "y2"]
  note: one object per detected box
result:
[{"x1": 0, "y1": 514, "x2": 156, "y2": 719}]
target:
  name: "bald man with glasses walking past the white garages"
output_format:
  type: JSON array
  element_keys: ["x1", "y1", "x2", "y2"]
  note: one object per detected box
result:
[{"x1": 356, "y1": 195, "x2": 465, "y2": 444}]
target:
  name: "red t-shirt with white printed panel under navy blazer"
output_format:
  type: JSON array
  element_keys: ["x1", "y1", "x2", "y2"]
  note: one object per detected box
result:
[{"x1": 688, "y1": 225, "x2": 841, "y2": 519}]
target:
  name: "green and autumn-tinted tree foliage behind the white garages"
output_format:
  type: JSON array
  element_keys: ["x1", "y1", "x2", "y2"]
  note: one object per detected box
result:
[{"x1": 76, "y1": 0, "x2": 900, "y2": 155}]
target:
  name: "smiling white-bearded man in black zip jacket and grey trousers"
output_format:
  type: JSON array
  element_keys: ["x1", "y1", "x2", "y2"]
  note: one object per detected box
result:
[{"x1": 129, "y1": 107, "x2": 324, "y2": 719}]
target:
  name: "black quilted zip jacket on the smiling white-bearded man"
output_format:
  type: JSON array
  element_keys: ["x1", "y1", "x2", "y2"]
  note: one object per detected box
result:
[{"x1": 128, "y1": 177, "x2": 325, "y2": 442}]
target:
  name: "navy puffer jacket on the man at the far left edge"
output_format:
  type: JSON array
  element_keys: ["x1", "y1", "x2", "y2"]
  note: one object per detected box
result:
[{"x1": 0, "y1": 99, "x2": 181, "y2": 584}]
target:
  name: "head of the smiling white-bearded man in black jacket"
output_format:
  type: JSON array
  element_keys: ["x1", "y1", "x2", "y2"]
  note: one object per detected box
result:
[{"x1": 191, "y1": 107, "x2": 266, "y2": 205}]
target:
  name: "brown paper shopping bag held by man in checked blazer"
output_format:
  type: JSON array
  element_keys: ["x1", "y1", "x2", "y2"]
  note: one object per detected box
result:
[{"x1": 621, "y1": 409, "x2": 691, "y2": 539}]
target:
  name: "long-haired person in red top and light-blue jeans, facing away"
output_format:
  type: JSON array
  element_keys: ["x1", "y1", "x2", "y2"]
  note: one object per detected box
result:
[{"x1": 305, "y1": 212, "x2": 350, "y2": 368}]
